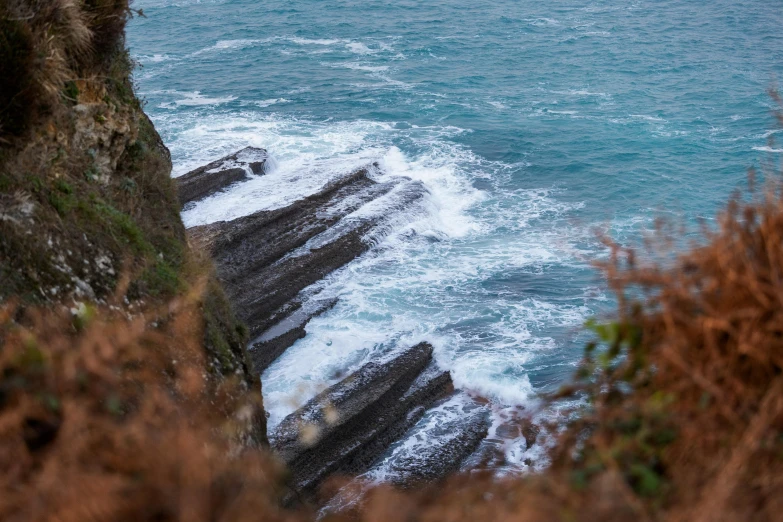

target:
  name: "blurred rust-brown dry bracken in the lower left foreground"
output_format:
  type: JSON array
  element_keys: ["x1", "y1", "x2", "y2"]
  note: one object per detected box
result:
[{"x1": 0, "y1": 282, "x2": 300, "y2": 521}]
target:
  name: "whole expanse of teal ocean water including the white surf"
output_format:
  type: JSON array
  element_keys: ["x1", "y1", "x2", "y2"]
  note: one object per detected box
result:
[{"x1": 128, "y1": 0, "x2": 783, "y2": 468}]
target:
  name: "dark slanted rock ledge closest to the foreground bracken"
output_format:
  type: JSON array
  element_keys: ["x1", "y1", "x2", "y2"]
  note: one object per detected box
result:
[{"x1": 270, "y1": 343, "x2": 453, "y2": 496}]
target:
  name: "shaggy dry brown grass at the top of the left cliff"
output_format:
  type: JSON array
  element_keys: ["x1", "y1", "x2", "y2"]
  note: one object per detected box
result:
[{"x1": 0, "y1": 0, "x2": 132, "y2": 140}]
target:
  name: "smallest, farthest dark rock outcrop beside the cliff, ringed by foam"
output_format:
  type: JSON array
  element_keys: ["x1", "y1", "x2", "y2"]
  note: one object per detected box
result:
[{"x1": 176, "y1": 147, "x2": 269, "y2": 207}]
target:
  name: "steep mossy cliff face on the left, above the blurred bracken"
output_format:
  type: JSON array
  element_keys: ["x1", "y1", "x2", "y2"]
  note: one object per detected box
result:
[{"x1": 0, "y1": 0, "x2": 265, "y2": 438}]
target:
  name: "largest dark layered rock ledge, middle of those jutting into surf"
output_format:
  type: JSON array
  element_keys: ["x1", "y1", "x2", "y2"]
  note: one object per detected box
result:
[{"x1": 189, "y1": 166, "x2": 426, "y2": 352}]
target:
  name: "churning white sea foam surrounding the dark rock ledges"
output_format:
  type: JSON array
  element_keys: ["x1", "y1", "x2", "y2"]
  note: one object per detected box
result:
[{"x1": 150, "y1": 106, "x2": 592, "y2": 472}]
